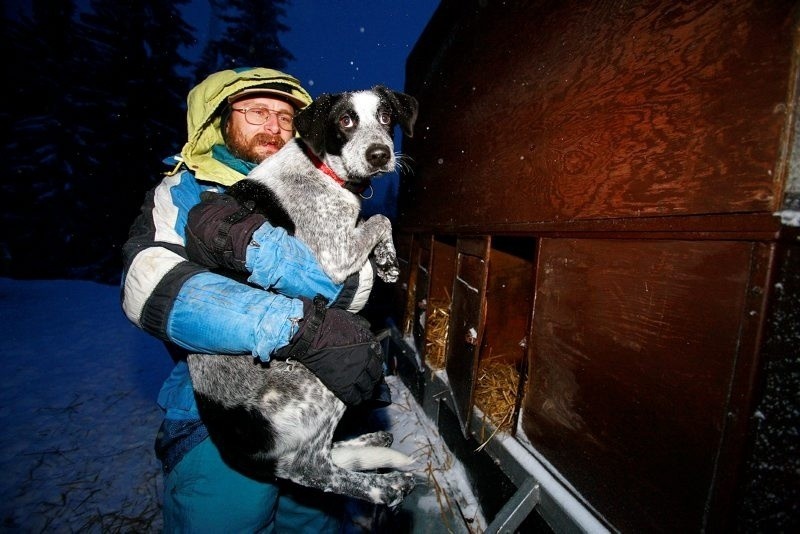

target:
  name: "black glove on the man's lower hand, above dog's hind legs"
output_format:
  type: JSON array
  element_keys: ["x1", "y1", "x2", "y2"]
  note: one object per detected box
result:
[{"x1": 273, "y1": 295, "x2": 388, "y2": 406}]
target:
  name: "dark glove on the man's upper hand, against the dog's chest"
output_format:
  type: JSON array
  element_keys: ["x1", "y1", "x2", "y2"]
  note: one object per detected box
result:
[{"x1": 186, "y1": 192, "x2": 265, "y2": 272}]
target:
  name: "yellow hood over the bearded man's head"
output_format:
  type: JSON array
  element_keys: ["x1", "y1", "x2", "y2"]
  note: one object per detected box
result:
[{"x1": 181, "y1": 68, "x2": 311, "y2": 186}]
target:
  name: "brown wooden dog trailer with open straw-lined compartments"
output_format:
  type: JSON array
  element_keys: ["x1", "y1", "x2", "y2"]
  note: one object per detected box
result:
[{"x1": 384, "y1": 0, "x2": 800, "y2": 532}]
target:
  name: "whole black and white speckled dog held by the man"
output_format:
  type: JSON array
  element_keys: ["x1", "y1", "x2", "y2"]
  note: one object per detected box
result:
[{"x1": 188, "y1": 86, "x2": 417, "y2": 506}]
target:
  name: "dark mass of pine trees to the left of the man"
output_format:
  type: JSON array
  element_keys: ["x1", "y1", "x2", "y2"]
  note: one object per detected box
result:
[{"x1": 0, "y1": 0, "x2": 192, "y2": 282}]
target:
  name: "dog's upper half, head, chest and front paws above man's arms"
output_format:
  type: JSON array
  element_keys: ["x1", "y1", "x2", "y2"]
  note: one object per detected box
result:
[{"x1": 228, "y1": 86, "x2": 417, "y2": 283}]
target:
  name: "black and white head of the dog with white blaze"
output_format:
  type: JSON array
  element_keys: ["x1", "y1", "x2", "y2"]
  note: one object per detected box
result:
[{"x1": 294, "y1": 85, "x2": 418, "y2": 187}]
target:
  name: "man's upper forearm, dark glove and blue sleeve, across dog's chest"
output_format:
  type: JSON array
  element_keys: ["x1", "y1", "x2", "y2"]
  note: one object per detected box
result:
[{"x1": 186, "y1": 192, "x2": 374, "y2": 312}]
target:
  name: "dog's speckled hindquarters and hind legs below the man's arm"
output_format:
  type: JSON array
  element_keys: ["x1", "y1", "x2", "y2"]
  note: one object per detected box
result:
[{"x1": 189, "y1": 354, "x2": 415, "y2": 506}]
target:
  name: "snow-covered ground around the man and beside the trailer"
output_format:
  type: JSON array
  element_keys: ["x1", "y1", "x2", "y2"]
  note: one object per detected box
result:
[{"x1": 0, "y1": 278, "x2": 484, "y2": 533}]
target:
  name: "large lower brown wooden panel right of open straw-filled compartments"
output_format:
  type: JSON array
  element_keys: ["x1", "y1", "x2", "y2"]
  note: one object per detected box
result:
[{"x1": 523, "y1": 239, "x2": 754, "y2": 532}]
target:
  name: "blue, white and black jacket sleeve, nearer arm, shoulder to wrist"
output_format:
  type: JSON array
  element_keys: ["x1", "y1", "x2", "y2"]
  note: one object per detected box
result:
[{"x1": 121, "y1": 172, "x2": 302, "y2": 360}]
